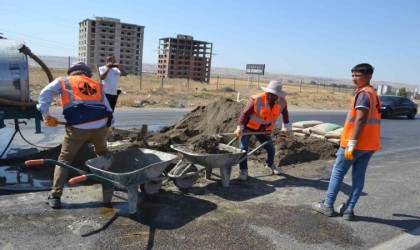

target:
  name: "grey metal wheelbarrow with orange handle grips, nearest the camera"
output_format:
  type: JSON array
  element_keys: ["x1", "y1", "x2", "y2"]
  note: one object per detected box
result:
[{"x1": 25, "y1": 148, "x2": 177, "y2": 214}]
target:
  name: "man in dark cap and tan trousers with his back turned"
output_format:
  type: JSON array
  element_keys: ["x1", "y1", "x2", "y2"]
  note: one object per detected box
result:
[{"x1": 37, "y1": 62, "x2": 113, "y2": 209}]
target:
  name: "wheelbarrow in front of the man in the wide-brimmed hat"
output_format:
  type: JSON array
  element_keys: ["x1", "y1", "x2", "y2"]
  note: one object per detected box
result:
[{"x1": 168, "y1": 138, "x2": 268, "y2": 189}]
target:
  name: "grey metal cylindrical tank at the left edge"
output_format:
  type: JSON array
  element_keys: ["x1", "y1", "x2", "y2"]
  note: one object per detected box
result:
[{"x1": 0, "y1": 39, "x2": 30, "y2": 102}]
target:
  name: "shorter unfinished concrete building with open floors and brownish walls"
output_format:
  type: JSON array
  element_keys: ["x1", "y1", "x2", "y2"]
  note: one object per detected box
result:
[{"x1": 158, "y1": 35, "x2": 213, "y2": 83}]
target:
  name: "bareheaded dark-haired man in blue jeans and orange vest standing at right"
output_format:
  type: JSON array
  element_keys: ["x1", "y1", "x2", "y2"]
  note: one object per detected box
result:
[{"x1": 312, "y1": 63, "x2": 381, "y2": 220}]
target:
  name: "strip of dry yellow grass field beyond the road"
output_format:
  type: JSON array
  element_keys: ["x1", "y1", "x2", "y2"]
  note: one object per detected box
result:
[{"x1": 29, "y1": 68, "x2": 353, "y2": 109}]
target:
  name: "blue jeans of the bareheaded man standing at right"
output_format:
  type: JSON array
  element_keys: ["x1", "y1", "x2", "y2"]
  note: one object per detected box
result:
[{"x1": 324, "y1": 147, "x2": 375, "y2": 209}]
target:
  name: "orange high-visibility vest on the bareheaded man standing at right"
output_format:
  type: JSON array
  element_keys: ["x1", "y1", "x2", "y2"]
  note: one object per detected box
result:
[{"x1": 340, "y1": 85, "x2": 381, "y2": 150}]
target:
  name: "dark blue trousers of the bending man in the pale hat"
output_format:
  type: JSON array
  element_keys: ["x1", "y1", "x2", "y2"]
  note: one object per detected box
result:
[{"x1": 239, "y1": 135, "x2": 275, "y2": 170}]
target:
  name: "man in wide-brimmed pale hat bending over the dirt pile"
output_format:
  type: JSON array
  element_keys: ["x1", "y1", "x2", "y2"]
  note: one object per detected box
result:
[{"x1": 234, "y1": 80, "x2": 292, "y2": 181}]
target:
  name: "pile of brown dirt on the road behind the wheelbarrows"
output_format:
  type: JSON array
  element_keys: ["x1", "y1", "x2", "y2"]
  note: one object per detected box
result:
[{"x1": 143, "y1": 99, "x2": 337, "y2": 166}]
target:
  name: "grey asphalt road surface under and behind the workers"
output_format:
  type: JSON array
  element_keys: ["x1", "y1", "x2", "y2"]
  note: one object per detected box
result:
[{"x1": 0, "y1": 109, "x2": 420, "y2": 249}]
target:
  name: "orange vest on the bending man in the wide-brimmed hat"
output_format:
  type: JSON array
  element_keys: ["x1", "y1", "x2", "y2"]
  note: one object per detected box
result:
[{"x1": 246, "y1": 92, "x2": 286, "y2": 131}]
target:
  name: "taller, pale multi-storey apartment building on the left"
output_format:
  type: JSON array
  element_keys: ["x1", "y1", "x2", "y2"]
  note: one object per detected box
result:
[{"x1": 79, "y1": 17, "x2": 144, "y2": 75}]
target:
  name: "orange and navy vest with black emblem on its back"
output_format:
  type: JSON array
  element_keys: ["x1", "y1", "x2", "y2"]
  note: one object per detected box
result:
[{"x1": 60, "y1": 75, "x2": 109, "y2": 126}]
